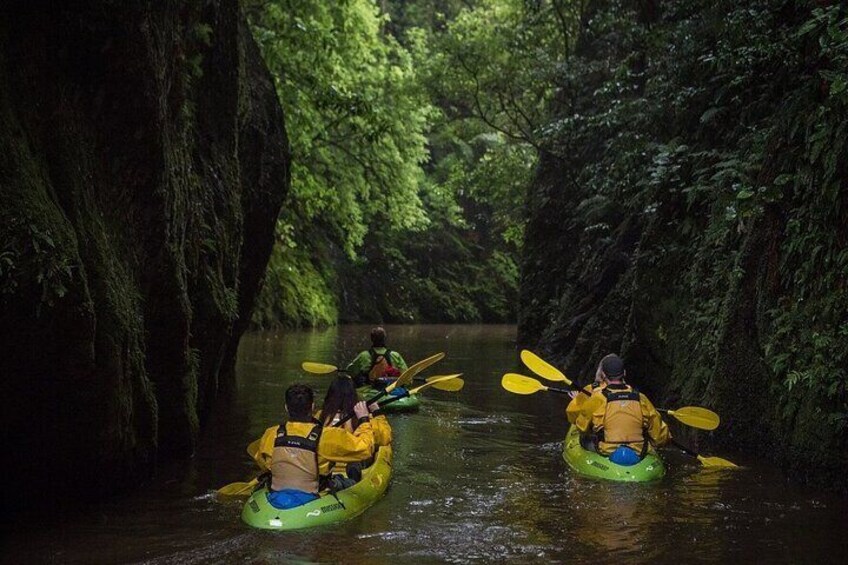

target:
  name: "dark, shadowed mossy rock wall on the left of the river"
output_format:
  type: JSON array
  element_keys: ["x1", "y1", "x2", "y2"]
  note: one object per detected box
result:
[{"x1": 0, "y1": 0, "x2": 289, "y2": 500}]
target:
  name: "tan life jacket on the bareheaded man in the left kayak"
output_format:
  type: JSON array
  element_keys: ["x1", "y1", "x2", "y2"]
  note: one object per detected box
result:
[{"x1": 270, "y1": 418, "x2": 324, "y2": 493}]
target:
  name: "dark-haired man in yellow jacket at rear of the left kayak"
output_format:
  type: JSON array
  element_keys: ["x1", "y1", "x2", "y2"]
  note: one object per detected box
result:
[{"x1": 248, "y1": 384, "x2": 374, "y2": 508}]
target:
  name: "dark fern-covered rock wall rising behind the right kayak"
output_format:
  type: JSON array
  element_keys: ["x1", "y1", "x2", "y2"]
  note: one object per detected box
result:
[{"x1": 519, "y1": 0, "x2": 848, "y2": 489}]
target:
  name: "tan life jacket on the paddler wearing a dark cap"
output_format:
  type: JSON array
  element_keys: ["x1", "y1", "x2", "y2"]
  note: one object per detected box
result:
[{"x1": 598, "y1": 385, "x2": 648, "y2": 457}]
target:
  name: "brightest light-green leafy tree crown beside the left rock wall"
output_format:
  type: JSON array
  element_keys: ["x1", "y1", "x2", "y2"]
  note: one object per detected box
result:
[{"x1": 248, "y1": 0, "x2": 432, "y2": 257}]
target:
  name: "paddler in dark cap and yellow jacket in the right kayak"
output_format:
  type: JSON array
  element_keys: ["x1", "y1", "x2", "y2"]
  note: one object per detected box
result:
[{"x1": 566, "y1": 354, "x2": 671, "y2": 465}]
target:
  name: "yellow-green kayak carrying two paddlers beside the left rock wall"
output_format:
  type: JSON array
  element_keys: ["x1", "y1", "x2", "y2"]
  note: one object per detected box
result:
[{"x1": 241, "y1": 446, "x2": 392, "y2": 530}]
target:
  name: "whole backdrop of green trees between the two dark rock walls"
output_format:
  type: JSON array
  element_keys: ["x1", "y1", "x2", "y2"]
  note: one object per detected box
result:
[{"x1": 246, "y1": 0, "x2": 540, "y2": 326}]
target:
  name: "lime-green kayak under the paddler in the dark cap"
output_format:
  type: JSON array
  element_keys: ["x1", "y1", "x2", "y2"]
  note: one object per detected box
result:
[{"x1": 562, "y1": 426, "x2": 665, "y2": 483}]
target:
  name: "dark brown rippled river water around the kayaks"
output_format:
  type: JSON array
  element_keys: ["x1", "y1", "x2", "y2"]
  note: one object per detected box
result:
[{"x1": 0, "y1": 326, "x2": 848, "y2": 564}]
